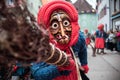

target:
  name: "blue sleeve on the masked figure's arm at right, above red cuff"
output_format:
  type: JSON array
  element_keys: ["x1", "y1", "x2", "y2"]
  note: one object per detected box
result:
[{"x1": 72, "y1": 32, "x2": 87, "y2": 66}]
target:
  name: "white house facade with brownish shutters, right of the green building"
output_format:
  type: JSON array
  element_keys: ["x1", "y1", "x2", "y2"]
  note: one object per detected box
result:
[{"x1": 97, "y1": 0, "x2": 111, "y2": 32}]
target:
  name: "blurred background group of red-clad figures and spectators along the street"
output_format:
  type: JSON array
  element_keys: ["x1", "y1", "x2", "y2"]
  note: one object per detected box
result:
[{"x1": 84, "y1": 24, "x2": 120, "y2": 57}]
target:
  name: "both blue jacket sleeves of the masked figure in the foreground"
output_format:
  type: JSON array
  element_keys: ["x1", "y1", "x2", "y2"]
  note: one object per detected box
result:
[{"x1": 31, "y1": 32, "x2": 87, "y2": 80}]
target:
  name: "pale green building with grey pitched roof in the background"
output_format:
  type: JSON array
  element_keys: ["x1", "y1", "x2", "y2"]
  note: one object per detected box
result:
[{"x1": 74, "y1": 0, "x2": 97, "y2": 33}]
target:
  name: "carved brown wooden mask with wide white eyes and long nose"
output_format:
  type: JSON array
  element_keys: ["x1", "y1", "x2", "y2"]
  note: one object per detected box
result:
[{"x1": 50, "y1": 11, "x2": 72, "y2": 44}]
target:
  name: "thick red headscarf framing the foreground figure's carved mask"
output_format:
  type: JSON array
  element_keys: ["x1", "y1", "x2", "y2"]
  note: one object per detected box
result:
[{"x1": 38, "y1": 0, "x2": 80, "y2": 50}]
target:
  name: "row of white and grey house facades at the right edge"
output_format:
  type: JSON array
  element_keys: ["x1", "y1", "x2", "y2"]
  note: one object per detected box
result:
[{"x1": 97, "y1": 0, "x2": 120, "y2": 31}]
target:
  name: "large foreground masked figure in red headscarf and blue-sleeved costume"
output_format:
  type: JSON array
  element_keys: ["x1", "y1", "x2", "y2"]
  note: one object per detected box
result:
[{"x1": 32, "y1": 0, "x2": 89, "y2": 80}]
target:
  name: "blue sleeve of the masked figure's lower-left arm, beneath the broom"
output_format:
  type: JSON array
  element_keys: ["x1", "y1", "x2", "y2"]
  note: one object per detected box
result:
[{"x1": 31, "y1": 62, "x2": 60, "y2": 80}]
